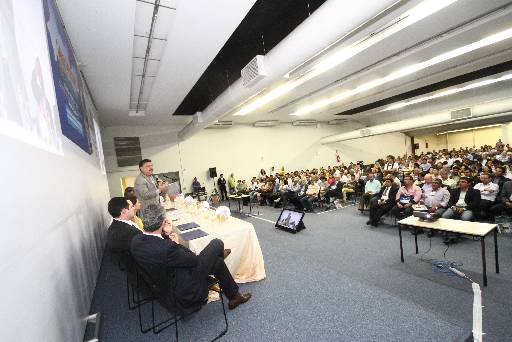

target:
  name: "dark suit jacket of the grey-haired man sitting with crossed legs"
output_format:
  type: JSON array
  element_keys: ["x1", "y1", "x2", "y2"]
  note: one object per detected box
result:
[{"x1": 130, "y1": 234, "x2": 208, "y2": 313}]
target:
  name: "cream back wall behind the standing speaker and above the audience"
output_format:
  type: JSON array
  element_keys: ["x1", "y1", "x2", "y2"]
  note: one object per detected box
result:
[{"x1": 103, "y1": 124, "x2": 409, "y2": 196}]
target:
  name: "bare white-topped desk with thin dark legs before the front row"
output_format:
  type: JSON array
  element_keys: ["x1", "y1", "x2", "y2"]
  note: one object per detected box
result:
[{"x1": 398, "y1": 216, "x2": 500, "y2": 286}]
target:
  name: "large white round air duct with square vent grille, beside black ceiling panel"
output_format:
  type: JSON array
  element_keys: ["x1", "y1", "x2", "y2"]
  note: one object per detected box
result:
[{"x1": 178, "y1": 0, "x2": 402, "y2": 140}]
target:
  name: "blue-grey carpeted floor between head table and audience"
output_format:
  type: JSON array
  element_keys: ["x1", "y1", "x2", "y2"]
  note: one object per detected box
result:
[{"x1": 87, "y1": 202, "x2": 512, "y2": 341}]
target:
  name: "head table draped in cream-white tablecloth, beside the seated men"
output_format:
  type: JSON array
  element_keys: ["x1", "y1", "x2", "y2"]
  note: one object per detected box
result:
[{"x1": 168, "y1": 210, "x2": 266, "y2": 283}]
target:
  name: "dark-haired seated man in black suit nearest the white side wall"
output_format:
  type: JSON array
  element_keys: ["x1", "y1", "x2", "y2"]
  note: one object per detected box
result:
[{"x1": 107, "y1": 197, "x2": 142, "y2": 254}]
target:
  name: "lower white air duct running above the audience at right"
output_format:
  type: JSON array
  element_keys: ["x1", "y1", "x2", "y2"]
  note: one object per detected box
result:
[{"x1": 320, "y1": 97, "x2": 512, "y2": 145}]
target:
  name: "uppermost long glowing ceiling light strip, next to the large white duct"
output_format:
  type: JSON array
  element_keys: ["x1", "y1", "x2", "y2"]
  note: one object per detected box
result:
[{"x1": 233, "y1": 0, "x2": 458, "y2": 116}]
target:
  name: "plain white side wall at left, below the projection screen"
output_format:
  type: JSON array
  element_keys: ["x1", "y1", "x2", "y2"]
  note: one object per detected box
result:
[{"x1": 0, "y1": 1, "x2": 109, "y2": 342}]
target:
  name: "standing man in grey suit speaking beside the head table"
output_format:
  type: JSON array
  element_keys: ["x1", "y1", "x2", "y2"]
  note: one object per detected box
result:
[{"x1": 135, "y1": 159, "x2": 168, "y2": 213}]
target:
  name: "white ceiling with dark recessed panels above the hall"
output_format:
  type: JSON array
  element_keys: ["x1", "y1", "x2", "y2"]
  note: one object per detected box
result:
[{"x1": 58, "y1": 0, "x2": 512, "y2": 136}]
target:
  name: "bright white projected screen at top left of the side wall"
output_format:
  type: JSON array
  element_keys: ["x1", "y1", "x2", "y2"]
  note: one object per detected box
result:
[{"x1": 0, "y1": 0, "x2": 62, "y2": 153}]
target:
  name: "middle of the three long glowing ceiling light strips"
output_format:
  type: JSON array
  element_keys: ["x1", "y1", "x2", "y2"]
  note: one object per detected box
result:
[{"x1": 290, "y1": 28, "x2": 512, "y2": 116}]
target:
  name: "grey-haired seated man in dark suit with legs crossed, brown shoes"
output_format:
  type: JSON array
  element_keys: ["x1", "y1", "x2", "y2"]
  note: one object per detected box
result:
[{"x1": 130, "y1": 204, "x2": 251, "y2": 313}]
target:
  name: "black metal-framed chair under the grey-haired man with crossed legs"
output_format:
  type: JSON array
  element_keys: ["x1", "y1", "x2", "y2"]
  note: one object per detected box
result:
[{"x1": 135, "y1": 262, "x2": 228, "y2": 341}]
